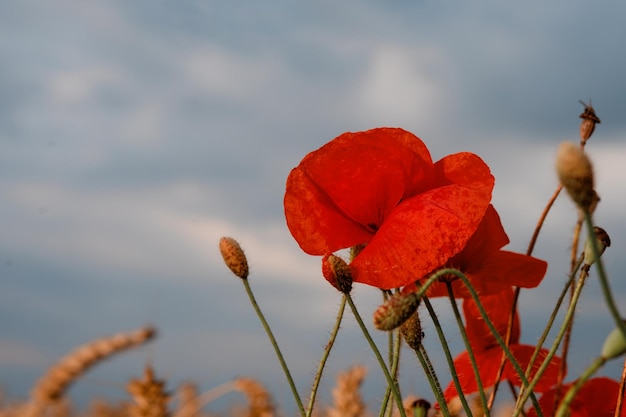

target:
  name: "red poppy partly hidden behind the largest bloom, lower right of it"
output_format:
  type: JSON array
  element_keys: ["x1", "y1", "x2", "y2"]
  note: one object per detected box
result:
[{"x1": 405, "y1": 205, "x2": 548, "y2": 298}]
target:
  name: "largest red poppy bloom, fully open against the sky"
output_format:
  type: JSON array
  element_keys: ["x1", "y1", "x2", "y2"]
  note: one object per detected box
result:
[{"x1": 284, "y1": 128, "x2": 494, "y2": 289}]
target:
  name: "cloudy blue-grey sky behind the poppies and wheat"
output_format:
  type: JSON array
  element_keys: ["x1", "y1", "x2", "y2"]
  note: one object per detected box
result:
[{"x1": 0, "y1": 0, "x2": 626, "y2": 410}]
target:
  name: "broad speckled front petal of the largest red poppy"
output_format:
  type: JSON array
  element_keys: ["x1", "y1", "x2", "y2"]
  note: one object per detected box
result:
[{"x1": 350, "y1": 180, "x2": 491, "y2": 289}]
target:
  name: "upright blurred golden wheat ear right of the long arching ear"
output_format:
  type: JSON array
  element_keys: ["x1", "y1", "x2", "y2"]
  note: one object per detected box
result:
[{"x1": 126, "y1": 366, "x2": 170, "y2": 417}]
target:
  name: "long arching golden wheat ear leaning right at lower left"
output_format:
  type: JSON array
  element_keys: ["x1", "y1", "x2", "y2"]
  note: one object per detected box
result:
[{"x1": 31, "y1": 326, "x2": 156, "y2": 404}]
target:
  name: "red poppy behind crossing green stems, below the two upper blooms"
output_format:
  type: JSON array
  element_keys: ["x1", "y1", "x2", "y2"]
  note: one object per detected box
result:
[{"x1": 444, "y1": 288, "x2": 561, "y2": 401}]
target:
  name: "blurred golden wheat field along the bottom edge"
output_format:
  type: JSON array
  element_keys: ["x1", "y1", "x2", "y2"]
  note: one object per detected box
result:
[{"x1": 0, "y1": 327, "x2": 507, "y2": 417}]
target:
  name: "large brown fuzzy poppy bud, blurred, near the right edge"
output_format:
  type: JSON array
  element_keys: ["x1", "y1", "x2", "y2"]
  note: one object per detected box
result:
[{"x1": 556, "y1": 142, "x2": 595, "y2": 211}]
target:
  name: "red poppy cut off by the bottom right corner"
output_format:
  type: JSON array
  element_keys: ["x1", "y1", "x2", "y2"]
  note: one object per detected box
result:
[{"x1": 526, "y1": 377, "x2": 626, "y2": 417}]
